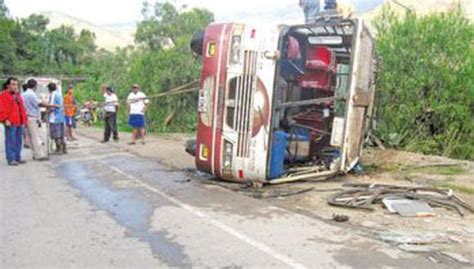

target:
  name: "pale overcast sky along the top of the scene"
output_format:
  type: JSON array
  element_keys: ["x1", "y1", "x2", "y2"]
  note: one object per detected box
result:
[{"x1": 5, "y1": 0, "x2": 382, "y2": 25}]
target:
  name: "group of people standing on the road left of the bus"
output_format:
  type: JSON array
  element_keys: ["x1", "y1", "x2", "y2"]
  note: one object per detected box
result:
[{"x1": 0, "y1": 77, "x2": 149, "y2": 166}]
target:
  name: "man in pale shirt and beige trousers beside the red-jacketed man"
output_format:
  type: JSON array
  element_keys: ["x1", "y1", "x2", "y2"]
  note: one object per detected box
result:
[{"x1": 21, "y1": 79, "x2": 48, "y2": 161}]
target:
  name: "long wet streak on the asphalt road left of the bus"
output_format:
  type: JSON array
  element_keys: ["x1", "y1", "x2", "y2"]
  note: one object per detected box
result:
[{"x1": 57, "y1": 162, "x2": 191, "y2": 268}]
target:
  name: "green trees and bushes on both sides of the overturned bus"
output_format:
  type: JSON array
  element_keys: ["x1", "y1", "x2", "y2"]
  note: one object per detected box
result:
[{"x1": 0, "y1": 0, "x2": 474, "y2": 159}]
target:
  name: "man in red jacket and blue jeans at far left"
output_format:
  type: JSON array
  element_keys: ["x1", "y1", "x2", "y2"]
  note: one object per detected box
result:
[{"x1": 0, "y1": 78, "x2": 28, "y2": 166}]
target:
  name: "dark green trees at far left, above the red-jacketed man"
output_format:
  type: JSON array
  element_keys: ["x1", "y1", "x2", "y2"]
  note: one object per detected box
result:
[{"x1": 0, "y1": 0, "x2": 96, "y2": 75}]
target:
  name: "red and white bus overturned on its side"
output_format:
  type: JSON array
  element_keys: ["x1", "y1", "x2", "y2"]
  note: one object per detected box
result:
[{"x1": 191, "y1": 18, "x2": 376, "y2": 183}]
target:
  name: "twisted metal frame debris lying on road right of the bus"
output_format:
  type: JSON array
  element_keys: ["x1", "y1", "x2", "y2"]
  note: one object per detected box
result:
[{"x1": 328, "y1": 183, "x2": 474, "y2": 216}]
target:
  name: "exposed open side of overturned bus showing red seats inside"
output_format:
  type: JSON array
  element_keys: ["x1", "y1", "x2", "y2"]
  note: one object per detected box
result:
[{"x1": 269, "y1": 20, "x2": 375, "y2": 183}]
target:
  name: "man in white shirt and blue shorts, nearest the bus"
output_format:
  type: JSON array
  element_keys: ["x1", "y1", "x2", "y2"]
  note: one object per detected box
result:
[{"x1": 127, "y1": 84, "x2": 150, "y2": 145}]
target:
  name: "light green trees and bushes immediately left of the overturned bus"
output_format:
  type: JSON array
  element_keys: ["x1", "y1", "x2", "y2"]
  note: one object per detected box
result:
[{"x1": 80, "y1": 2, "x2": 213, "y2": 132}]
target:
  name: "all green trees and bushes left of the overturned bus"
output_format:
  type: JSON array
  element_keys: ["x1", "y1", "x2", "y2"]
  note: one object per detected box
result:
[{"x1": 0, "y1": 0, "x2": 213, "y2": 132}]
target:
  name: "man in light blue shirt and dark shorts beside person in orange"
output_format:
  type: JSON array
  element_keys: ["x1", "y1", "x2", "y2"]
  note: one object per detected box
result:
[{"x1": 48, "y1": 83, "x2": 67, "y2": 154}]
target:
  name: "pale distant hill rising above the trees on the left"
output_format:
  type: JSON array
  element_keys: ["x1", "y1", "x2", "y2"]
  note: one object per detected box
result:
[{"x1": 39, "y1": 11, "x2": 135, "y2": 51}]
